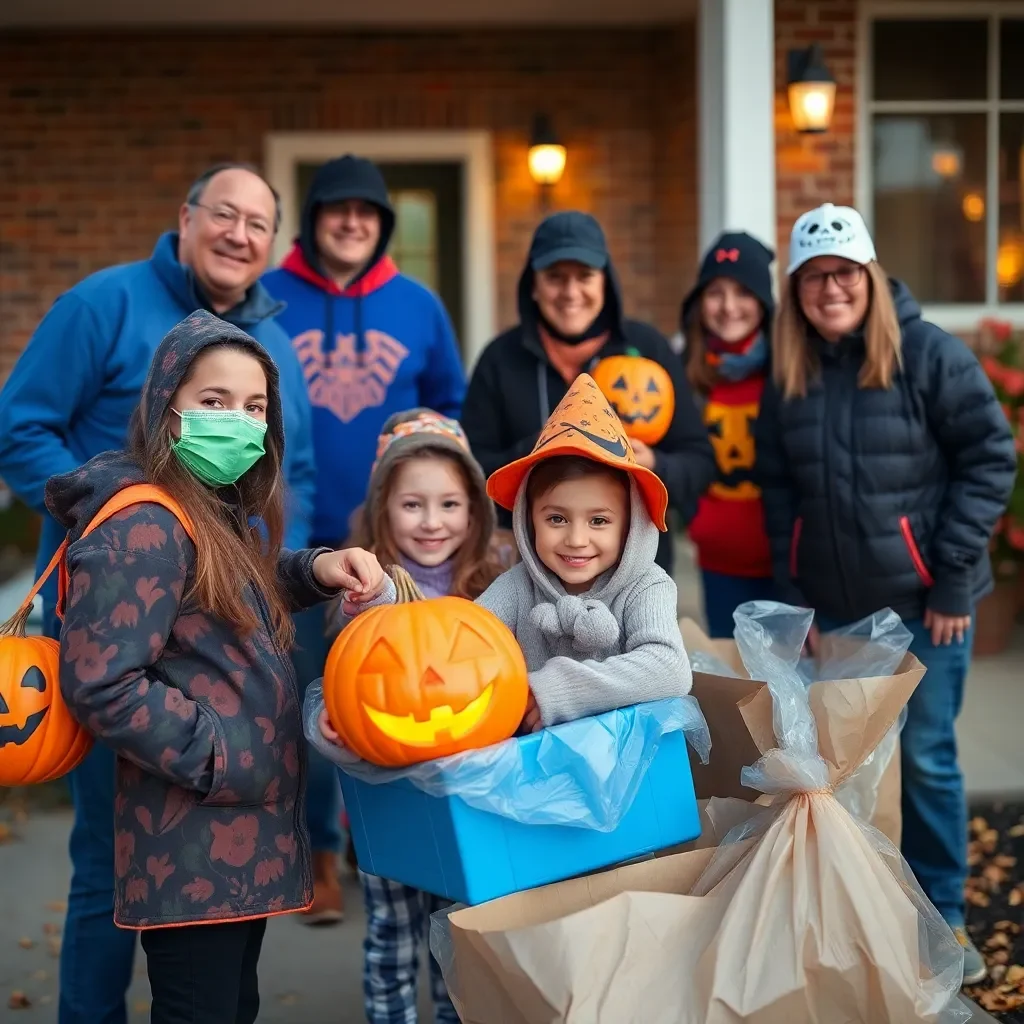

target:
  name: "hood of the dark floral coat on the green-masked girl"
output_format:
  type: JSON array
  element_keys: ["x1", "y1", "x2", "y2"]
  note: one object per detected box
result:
[{"x1": 46, "y1": 309, "x2": 285, "y2": 541}]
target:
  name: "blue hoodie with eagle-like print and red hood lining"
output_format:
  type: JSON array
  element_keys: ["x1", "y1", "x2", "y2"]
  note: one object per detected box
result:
[{"x1": 263, "y1": 246, "x2": 466, "y2": 546}]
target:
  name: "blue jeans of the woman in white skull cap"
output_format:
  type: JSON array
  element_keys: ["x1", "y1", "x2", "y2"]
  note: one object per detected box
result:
[{"x1": 818, "y1": 616, "x2": 974, "y2": 927}]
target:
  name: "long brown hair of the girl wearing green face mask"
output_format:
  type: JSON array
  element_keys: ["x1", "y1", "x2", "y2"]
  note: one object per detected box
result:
[{"x1": 127, "y1": 342, "x2": 295, "y2": 650}]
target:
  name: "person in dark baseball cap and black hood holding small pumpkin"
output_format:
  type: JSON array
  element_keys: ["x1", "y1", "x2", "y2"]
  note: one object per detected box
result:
[{"x1": 462, "y1": 210, "x2": 715, "y2": 571}]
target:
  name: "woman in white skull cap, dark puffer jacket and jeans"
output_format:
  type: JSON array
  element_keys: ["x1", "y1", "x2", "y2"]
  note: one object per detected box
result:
[{"x1": 755, "y1": 203, "x2": 1017, "y2": 983}]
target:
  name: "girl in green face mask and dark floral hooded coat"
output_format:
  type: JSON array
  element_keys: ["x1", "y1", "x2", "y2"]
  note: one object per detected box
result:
[{"x1": 46, "y1": 312, "x2": 384, "y2": 1024}]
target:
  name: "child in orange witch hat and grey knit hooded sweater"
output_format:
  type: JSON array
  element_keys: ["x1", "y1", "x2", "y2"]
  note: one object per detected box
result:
[{"x1": 306, "y1": 374, "x2": 692, "y2": 741}]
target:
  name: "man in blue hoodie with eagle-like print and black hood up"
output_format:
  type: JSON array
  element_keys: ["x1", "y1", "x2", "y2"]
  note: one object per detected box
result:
[{"x1": 263, "y1": 156, "x2": 466, "y2": 924}]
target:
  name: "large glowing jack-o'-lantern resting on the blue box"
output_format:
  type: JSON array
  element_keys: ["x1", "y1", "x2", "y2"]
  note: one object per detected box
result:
[{"x1": 324, "y1": 597, "x2": 528, "y2": 767}]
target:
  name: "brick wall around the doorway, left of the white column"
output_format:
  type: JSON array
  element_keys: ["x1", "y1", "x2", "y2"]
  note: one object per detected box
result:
[{"x1": 0, "y1": 25, "x2": 695, "y2": 375}]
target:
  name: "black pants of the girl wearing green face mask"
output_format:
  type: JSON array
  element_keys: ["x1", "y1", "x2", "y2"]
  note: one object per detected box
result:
[{"x1": 142, "y1": 918, "x2": 266, "y2": 1024}]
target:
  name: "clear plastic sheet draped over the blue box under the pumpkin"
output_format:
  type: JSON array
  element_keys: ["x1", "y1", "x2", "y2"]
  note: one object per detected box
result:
[{"x1": 303, "y1": 680, "x2": 711, "y2": 831}]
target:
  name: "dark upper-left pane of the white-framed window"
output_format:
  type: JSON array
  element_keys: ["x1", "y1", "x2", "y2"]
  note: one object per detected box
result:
[{"x1": 872, "y1": 18, "x2": 988, "y2": 99}]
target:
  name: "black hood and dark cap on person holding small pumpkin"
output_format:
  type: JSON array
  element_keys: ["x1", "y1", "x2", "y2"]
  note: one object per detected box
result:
[{"x1": 517, "y1": 210, "x2": 626, "y2": 353}]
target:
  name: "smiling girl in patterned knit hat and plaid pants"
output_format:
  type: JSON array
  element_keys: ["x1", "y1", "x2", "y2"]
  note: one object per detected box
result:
[{"x1": 317, "y1": 409, "x2": 504, "y2": 1024}]
